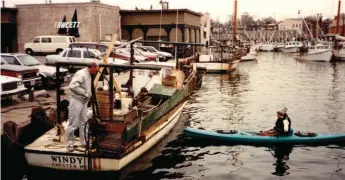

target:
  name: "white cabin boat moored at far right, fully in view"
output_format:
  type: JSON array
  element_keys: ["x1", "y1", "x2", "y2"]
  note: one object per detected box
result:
[{"x1": 294, "y1": 44, "x2": 333, "y2": 62}]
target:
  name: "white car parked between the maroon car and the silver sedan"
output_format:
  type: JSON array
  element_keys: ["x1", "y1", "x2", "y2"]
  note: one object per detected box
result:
[{"x1": 1, "y1": 53, "x2": 71, "y2": 87}]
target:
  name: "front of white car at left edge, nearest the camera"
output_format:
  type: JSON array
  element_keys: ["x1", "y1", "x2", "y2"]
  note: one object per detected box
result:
[{"x1": 0, "y1": 75, "x2": 27, "y2": 99}]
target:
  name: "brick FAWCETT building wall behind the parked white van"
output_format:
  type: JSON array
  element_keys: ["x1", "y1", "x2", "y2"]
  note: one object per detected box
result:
[{"x1": 16, "y1": 2, "x2": 120, "y2": 52}]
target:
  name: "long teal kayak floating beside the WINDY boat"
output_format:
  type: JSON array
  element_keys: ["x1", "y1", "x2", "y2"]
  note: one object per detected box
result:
[{"x1": 184, "y1": 128, "x2": 345, "y2": 145}]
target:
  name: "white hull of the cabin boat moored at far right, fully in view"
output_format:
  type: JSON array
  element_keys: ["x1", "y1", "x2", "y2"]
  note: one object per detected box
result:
[{"x1": 294, "y1": 50, "x2": 333, "y2": 62}]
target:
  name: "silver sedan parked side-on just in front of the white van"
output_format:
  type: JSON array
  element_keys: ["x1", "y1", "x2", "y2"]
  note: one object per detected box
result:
[{"x1": 46, "y1": 48, "x2": 129, "y2": 71}]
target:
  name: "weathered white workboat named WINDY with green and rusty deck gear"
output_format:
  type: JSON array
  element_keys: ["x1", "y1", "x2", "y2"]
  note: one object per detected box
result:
[{"x1": 24, "y1": 40, "x2": 199, "y2": 171}]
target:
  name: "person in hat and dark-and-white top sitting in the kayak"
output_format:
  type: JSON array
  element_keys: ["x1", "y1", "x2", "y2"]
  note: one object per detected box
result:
[{"x1": 259, "y1": 107, "x2": 292, "y2": 136}]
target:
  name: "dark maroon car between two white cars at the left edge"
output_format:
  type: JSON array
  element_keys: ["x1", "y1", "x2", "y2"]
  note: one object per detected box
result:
[{"x1": 1, "y1": 58, "x2": 42, "y2": 88}]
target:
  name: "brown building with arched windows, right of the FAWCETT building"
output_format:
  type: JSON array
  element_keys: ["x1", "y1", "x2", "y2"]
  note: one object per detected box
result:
[{"x1": 120, "y1": 9, "x2": 202, "y2": 43}]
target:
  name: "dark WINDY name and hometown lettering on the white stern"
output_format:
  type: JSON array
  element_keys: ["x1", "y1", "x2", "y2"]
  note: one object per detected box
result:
[{"x1": 51, "y1": 156, "x2": 86, "y2": 169}]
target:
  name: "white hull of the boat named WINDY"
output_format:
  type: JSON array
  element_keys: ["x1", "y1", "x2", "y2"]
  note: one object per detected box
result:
[{"x1": 25, "y1": 101, "x2": 187, "y2": 171}]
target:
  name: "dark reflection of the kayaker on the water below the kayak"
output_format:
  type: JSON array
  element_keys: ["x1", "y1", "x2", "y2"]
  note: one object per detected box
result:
[{"x1": 272, "y1": 146, "x2": 293, "y2": 176}]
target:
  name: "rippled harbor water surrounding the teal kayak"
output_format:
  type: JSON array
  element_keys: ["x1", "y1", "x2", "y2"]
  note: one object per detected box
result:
[{"x1": 29, "y1": 52, "x2": 345, "y2": 180}]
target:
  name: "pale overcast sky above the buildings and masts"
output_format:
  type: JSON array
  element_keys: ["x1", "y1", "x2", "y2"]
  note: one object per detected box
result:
[{"x1": 5, "y1": 0, "x2": 345, "y2": 22}]
